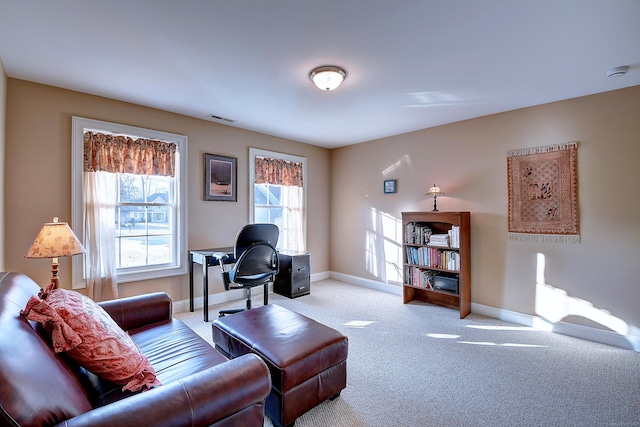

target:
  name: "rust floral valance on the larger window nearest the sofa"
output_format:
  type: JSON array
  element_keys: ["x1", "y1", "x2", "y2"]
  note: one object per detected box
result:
[{"x1": 84, "y1": 132, "x2": 176, "y2": 176}]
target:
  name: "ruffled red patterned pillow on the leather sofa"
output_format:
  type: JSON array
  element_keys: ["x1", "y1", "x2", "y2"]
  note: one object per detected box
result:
[{"x1": 20, "y1": 286, "x2": 161, "y2": 391}]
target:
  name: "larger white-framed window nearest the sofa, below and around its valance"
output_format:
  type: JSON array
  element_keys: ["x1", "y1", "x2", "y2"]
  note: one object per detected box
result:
[{"x1": 72, "y1": 117, "x2": 187, "y2": 288}]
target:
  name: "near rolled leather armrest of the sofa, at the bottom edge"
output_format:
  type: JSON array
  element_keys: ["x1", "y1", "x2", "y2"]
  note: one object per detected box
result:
[{"x1": 59, "y1": 354, "x2": 271, "y2": 427}]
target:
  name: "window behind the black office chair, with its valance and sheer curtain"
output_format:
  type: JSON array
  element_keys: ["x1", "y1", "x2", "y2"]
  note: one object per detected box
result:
[{"x1": 249, "y1": 148, "x2": 307, "y2": 252}]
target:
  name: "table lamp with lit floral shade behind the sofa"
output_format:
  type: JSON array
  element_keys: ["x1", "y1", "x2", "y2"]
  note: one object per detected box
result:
[{"x1": 25, "y1": 217, "x2": 85, "y2": 289}]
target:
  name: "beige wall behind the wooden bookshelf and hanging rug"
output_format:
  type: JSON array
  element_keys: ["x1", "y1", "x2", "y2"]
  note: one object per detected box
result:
[{"x1": 331, "y1": 86, "x2": 640, "y2": 336}]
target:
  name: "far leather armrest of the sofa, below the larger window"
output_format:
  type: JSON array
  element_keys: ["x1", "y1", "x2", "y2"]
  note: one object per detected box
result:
[{"x1": 98, "y1": 292, "x2": 173, "y2": 331}]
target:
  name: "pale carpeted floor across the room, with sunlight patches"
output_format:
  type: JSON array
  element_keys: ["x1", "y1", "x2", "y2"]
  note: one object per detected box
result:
[{"x1": 175, "y1": 280, "x2": 640, "y2": 427}]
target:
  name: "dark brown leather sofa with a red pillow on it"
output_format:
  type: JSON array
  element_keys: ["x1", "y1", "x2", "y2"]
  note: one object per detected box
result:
[{"x1": 0, "y1": 272, "x2": 271, "y2": 427}]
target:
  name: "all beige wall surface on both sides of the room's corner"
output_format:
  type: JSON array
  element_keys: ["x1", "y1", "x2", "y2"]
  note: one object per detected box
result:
[{"x1": 5, "y1": 73, "x2": 640, "y2": 344}]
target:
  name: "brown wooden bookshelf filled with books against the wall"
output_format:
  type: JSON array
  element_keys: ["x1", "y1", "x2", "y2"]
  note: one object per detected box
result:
[{"x1": 402, "y1": 212, "x2": 471, "y2": 319}]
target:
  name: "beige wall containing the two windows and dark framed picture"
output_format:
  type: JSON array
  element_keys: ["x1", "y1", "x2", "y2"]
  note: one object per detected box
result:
[{"x1": 3, "y1": 78, "x2": 330, "y2": 300}]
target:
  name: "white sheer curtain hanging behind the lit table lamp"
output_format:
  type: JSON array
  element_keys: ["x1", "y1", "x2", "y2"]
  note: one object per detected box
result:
[{"x1": 83, "y1": 172, "x2": 118, "y2": 301}]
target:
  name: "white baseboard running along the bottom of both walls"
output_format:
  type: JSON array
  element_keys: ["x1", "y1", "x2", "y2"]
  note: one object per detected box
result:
[{"x1": 173, "y1": 271, "x2": 640, "y2": 352}]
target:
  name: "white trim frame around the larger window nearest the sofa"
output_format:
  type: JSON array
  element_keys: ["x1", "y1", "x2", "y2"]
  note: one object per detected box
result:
[{"x1": 71, "y1": 116, "x2": 189, "y2": 289}]
